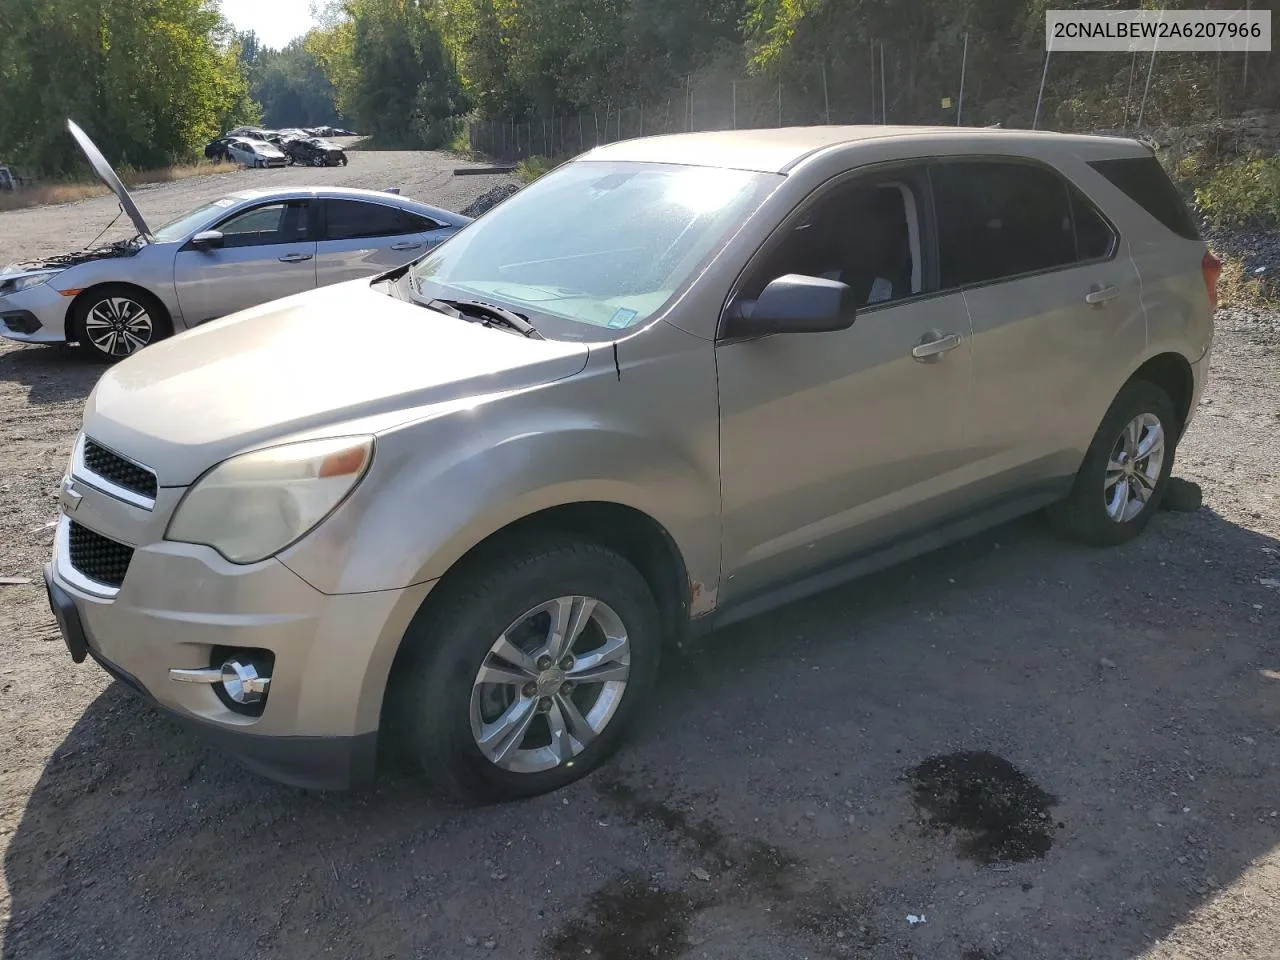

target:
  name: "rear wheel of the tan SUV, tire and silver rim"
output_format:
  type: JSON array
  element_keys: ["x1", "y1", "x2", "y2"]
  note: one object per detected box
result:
[{"x1": 1047, "y1": 380, "x2": 1181, "y2": 547}]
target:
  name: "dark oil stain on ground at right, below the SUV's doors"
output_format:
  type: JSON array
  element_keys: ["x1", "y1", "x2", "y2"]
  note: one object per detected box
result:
[{"x1": 908, "y1": 750, "x2": 1061, "y2": 864}]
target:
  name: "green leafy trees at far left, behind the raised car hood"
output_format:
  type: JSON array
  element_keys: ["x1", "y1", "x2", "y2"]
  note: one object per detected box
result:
[{"x1": 0, "y1": 0, "x2": 257, "y2": 174}]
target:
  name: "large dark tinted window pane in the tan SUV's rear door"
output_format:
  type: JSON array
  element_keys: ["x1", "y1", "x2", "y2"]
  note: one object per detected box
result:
[{"x1": 933, "y1": 161, "x2": 1080, "y2": 289}]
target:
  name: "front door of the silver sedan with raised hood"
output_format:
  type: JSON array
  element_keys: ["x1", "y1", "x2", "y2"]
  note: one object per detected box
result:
[{"x1": 174, "y1": 200, "x2": 316, "y2": 326}]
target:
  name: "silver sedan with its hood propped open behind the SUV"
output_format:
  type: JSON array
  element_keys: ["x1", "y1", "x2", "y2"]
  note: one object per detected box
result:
[{"x1": 0, "y1": 119, "x2": 470, "y2": 360}]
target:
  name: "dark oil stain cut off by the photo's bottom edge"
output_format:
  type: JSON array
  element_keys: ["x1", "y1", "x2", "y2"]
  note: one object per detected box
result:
[{"x1": 547, "y1": 874, "x2": 699, "y2": 960}]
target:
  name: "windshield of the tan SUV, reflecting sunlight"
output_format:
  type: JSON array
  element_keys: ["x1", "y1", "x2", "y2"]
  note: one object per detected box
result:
[{"x1": 412, "y1": 161, "x2": 782, "y2": 339}]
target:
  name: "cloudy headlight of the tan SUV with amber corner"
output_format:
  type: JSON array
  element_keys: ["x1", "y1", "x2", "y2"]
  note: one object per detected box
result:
[{"x1": 165, "y1": 436, "x2": 374, "y2": 563}]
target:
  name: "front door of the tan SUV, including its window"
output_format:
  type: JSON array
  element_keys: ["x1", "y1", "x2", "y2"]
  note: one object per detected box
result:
[{"x1": 717, "y1": 168, "x2": 973, "y2": 599}]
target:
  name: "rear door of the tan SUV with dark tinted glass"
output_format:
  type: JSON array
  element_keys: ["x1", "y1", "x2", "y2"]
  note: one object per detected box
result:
[{"x1": 932, "y1": 159, "x2": 1146, "y2": 497}]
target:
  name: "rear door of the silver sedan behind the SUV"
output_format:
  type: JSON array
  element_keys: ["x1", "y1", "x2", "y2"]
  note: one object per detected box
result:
[{"x1": 316, "y1": 198, "x2": 436, "y2": 287}]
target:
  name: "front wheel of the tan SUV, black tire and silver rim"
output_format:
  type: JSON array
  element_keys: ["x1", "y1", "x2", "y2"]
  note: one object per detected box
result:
[{"x1": 392, "y1": 538, "x2": 662, "y2": 803}]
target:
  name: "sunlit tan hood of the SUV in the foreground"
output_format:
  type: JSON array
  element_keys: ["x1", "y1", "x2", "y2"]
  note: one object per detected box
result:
[{"x1": 84, "y1": 279, "x2": 588, "y2": 486}]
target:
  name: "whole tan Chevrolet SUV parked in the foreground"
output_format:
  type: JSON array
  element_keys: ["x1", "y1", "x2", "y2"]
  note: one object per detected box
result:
[{"x1": 45, "y1": 125, "x2": 1219, "y2": 800}]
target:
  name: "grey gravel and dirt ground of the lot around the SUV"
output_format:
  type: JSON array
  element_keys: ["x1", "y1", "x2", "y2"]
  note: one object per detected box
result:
[{"x1": 0, "y1": 155, "x2": 1280, "y2": 960}]
